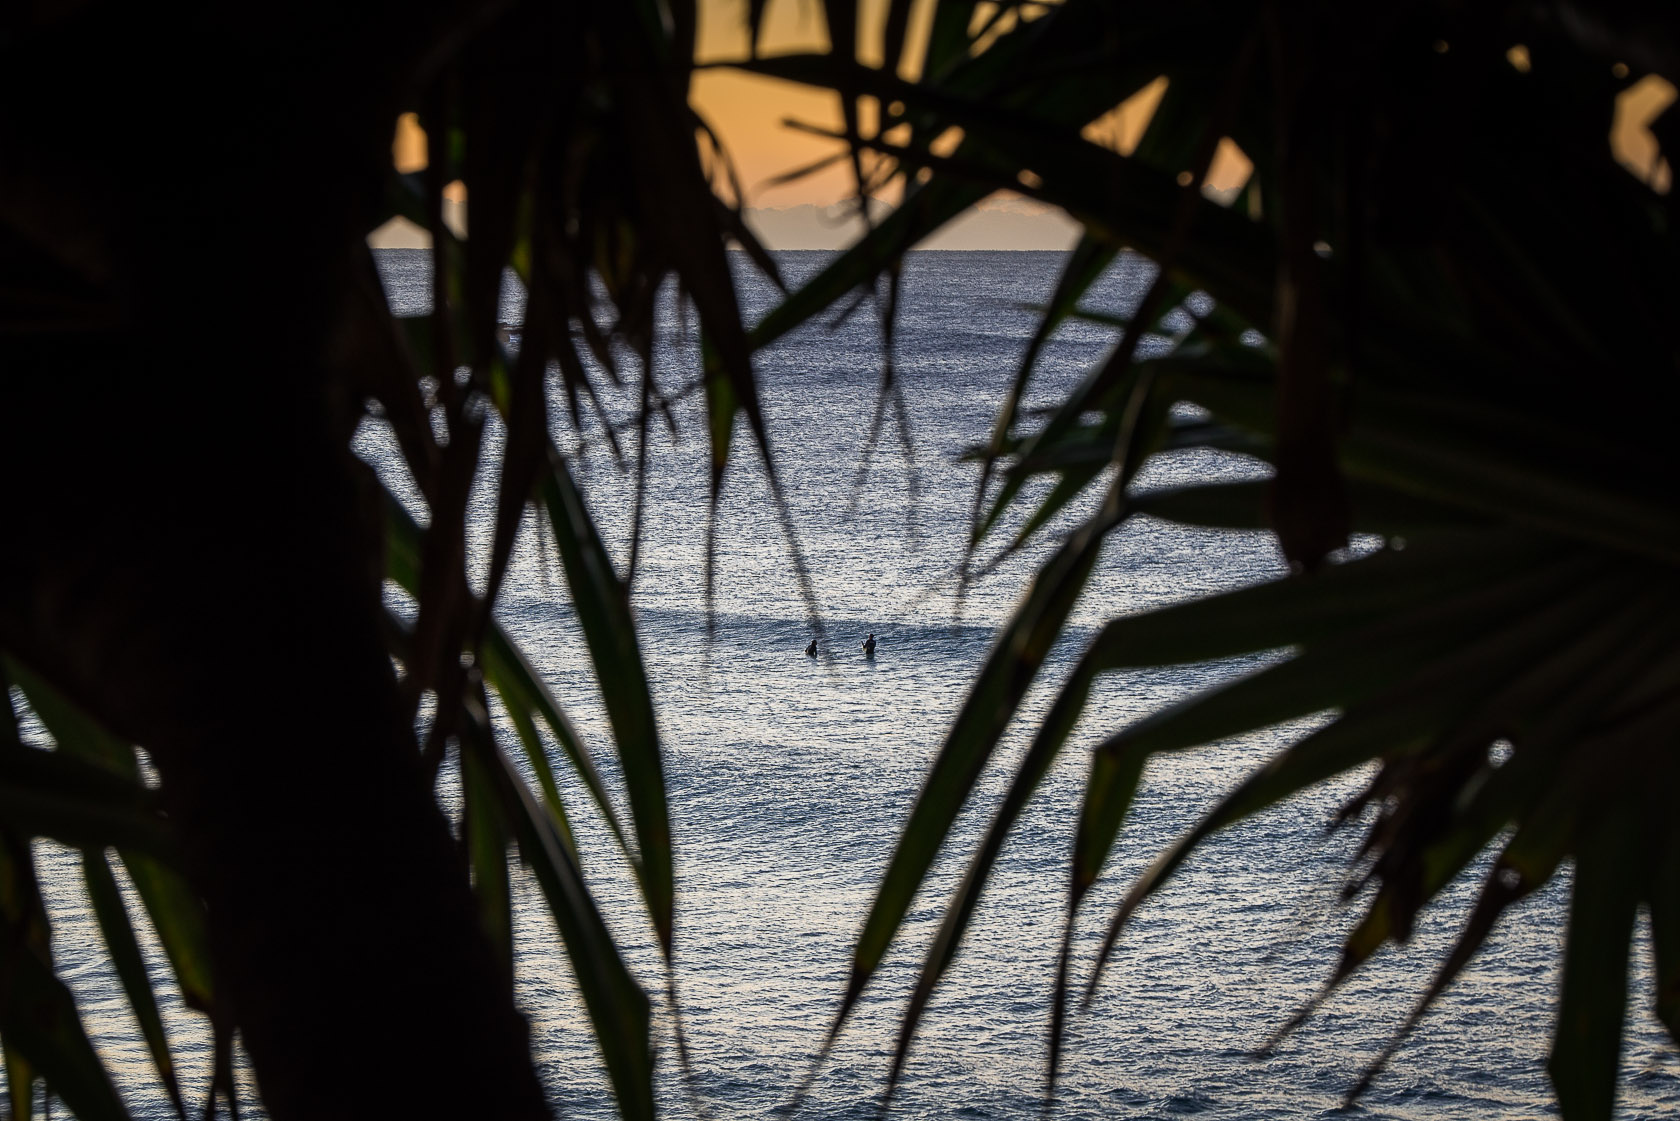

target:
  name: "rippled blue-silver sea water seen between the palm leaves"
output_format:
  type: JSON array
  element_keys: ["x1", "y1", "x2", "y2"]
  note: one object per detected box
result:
[{"x1": 16, "y1": 252, "x2": 1680, "y2": 1121}]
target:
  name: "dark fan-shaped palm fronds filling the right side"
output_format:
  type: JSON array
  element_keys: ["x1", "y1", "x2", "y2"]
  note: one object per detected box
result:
[{"x1": 753, "y1": 0, "x2": 1680, "y2": 1118}]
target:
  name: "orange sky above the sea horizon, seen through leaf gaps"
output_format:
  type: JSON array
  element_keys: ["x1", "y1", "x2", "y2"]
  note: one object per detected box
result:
[{"x1": 370, "y1": 0, "x2": 1675, "y2": 249}]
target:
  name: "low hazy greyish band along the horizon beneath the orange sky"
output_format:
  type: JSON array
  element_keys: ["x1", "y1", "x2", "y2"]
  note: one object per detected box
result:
[{"x1": 368, "y1": 195, "x2": 1079, "y2": 250}]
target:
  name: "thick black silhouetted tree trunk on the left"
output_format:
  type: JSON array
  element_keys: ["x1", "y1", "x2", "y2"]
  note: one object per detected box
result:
[{"x1": 0, "y1": 5, "x2": 546, "y2": 1119}]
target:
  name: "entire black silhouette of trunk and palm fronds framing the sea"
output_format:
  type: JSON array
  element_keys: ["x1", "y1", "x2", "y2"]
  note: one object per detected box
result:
[{"x1": 0, "y1": 0, "x2": 1680, "y2": 1121}]
